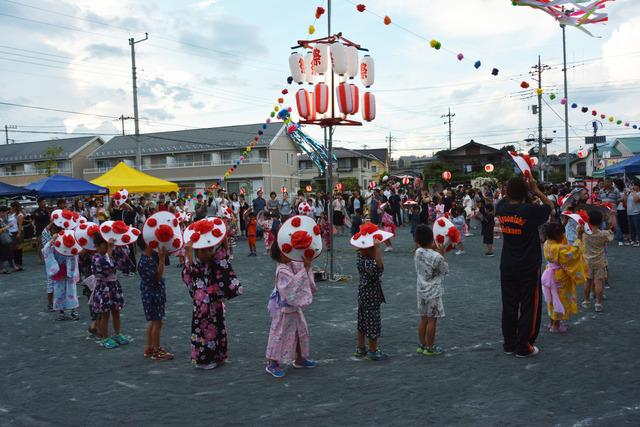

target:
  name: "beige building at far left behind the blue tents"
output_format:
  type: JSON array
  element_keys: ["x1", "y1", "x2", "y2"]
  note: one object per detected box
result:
[{"x1": 0, "y1": 136, "x2": 104, "y2": 185}]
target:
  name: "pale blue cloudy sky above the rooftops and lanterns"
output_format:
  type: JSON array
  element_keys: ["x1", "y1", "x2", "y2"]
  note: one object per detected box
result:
[{"x1": 0, "y1": 0, "x2": 640, "y2": 156}]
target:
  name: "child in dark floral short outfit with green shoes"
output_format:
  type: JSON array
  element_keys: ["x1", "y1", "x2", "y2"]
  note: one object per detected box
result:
[{"x1": 91, "y1": 233, "x2": 130, "y2": 349}]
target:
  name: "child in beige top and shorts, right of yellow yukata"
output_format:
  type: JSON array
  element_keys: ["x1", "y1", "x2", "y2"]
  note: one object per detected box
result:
[{"x1": 582, "y1": 209, "x2": 615, "y2": 313}]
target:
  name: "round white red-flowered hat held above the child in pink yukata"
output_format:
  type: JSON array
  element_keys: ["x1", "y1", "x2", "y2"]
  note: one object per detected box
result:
[{"x1": 277, "y1": 215, "x2": 322, "y2": 261}]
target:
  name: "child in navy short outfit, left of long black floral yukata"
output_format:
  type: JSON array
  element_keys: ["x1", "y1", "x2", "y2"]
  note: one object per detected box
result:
[{"x1": 138, "y1": 239, "x2": 174, "y2": 360}]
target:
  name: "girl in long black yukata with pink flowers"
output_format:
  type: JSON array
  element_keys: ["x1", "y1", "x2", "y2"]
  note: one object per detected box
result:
[{"x1": 182, "y1": 230, "x2": 242, "y2": 369}]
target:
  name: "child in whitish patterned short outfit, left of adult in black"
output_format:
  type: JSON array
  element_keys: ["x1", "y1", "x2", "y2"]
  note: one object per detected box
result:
[{"x1": 414, "y1": 224, "x2": 449, "y2": 356}]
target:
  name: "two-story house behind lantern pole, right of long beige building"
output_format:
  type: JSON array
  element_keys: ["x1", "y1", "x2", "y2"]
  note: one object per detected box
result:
[{"x1": 298, "y1": 147, "x2": 379, "y2": 188}]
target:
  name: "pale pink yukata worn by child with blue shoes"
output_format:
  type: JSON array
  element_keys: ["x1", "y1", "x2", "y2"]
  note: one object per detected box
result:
[{"x1": 266, "y1": 261, "x2": 316, "y2": 364}]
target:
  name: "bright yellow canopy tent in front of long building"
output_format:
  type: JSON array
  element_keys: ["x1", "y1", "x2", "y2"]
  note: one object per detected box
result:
[{"x1": 91, "y1": 162, "x2": 178, "y2": 194}]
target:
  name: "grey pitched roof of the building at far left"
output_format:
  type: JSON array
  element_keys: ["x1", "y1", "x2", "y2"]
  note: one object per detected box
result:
[{"x1": 0, "y1": 136, "x2": 102, "y2": 164}]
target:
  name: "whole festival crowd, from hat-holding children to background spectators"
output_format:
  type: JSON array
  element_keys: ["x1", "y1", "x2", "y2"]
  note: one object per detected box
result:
[{"x1": 0, "y1": 173, "x2": 640, "y2": 377}]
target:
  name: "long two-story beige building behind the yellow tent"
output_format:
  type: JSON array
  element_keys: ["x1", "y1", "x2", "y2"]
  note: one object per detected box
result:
[{"x1": 84, "y1": 123, "x2": 300, "y2": 199}]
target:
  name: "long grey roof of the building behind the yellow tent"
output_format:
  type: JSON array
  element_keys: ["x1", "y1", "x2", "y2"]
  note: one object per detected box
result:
[{"x1": 89, "y1": 123, "x2": 284, "y2": 159}]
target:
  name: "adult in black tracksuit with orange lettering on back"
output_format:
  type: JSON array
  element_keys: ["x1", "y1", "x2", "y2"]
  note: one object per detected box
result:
[{"x1": 496, "y1": 177, "x2": 553, "y2": 357}]
